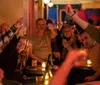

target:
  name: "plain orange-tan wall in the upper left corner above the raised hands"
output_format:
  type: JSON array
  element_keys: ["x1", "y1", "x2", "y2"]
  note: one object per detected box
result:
[{"x1": 0, "y1": 0, "x2": 24, "y2": 25}]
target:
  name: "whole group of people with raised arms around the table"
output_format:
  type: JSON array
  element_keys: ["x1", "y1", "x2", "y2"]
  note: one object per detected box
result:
[{"x1": 0, "y1": 6, "x2": 100, "y2": 85}]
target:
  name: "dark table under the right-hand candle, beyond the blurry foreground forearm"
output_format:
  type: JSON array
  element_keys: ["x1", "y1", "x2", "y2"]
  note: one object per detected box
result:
[{"x1": 68, "y1": 67, "x2": 93, "y2": 85}]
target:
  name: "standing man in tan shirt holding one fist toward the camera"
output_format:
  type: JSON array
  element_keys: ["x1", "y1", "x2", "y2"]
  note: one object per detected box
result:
[{"x1": 30, "y1": 18, "x2": 57, "y2": 62}]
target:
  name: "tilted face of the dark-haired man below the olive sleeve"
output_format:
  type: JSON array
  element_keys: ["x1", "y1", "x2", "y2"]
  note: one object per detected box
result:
[{"x1": 80, "y1": 32, "x2": 94, "y2": 48}]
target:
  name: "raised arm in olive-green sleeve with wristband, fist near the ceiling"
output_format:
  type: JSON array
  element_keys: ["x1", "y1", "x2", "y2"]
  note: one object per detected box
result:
[{"x1": 66, "y1": 5, "x2": 100, "y2": 43}]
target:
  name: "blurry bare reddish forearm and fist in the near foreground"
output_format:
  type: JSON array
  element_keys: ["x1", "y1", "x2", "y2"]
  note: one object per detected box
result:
[{"x1": 49, "y1": 50, "x2": 87, "y2": 85}]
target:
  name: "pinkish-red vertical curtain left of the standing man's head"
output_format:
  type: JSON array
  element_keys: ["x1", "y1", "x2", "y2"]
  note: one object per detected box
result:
[{"x1": 24, "y1": 0, "x2": 35, "y2": 37}]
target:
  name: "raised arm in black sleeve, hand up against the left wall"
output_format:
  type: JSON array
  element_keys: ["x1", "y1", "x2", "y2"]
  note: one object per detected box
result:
[{"x1": 0, "y1": 18, "x2": 23, "y2": 57}]
